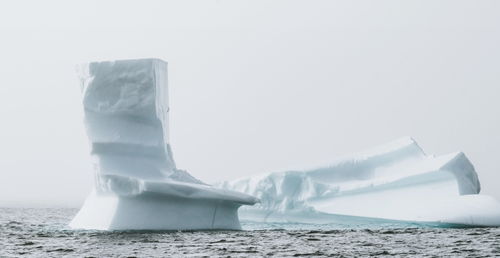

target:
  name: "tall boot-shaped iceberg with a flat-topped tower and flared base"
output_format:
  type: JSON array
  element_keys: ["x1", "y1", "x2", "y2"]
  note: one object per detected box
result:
[{"x1": 70, "y1": 59, "x2": 257, "y2": 230}]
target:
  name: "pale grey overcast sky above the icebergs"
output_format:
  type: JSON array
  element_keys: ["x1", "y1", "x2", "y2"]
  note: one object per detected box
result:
[{"x1": 0, "y1": 0, "x2": 500, "y2": 207}]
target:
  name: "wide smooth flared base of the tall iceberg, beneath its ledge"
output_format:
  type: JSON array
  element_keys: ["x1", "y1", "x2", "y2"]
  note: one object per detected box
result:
[{"x1": 69, "y1": 191, "x2": 241, "y2": 230}]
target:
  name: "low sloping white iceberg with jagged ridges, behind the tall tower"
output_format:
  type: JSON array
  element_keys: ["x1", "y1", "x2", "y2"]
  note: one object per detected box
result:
[{"x1": 218, "y1": 137, "x2": 500, "y2": 226}]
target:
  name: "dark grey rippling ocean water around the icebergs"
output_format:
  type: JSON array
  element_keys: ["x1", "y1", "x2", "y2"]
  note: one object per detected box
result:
[{"x1": 0, "y1": 208, "x2": 500, "y2": 257}]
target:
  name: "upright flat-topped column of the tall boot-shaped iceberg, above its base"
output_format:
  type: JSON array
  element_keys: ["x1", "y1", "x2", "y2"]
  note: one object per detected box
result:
[{"x1": 81, "y1": 59, "x2": 175, "y2": 179}]
